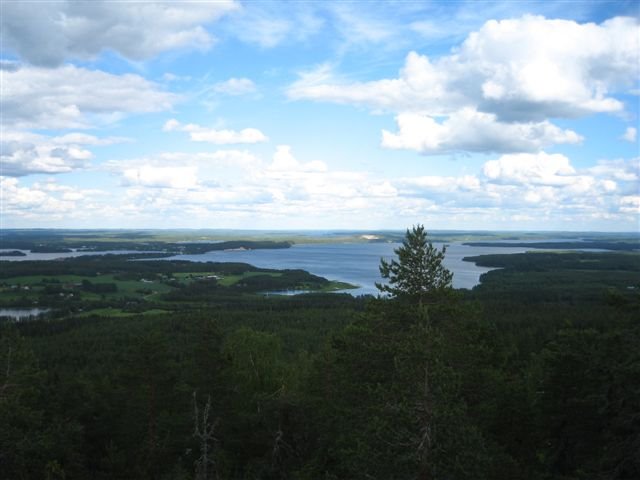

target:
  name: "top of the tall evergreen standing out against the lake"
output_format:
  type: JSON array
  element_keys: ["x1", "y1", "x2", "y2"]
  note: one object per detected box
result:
[{"x1": 376, "y1": 225, "x2": 453, "y2": 302}]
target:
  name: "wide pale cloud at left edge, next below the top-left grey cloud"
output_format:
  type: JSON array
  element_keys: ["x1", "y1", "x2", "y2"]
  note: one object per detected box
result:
[{"x1": 0, "y1": 65, "x2": 179, "y2": 129}]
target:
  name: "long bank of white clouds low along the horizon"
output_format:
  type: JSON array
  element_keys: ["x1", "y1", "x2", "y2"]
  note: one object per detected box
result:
[{"x1": 2, "y1": 145, "x2": 640, "y2": 230}]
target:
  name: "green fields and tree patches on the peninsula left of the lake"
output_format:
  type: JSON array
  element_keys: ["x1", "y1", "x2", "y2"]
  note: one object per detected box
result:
[{"x1": 0, "y1": 255, "x2": 354, "y2": 317}]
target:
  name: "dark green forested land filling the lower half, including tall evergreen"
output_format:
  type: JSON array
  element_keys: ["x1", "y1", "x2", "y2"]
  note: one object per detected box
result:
[{"x1": 0, "y1": 227, "x2": 640, "y2": 480}]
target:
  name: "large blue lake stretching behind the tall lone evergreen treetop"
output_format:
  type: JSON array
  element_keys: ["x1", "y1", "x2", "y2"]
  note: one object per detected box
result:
[{"x1": 161, "y1": 243, "x2": 527, "y2": 295}]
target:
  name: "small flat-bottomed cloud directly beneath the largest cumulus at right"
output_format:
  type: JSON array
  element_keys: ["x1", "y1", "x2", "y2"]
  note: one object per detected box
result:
[{"x1": 382, "y1": 108, "x2": 582, "y2": 154}]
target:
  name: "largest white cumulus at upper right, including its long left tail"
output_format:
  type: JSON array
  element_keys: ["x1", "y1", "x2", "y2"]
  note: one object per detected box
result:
[{"x1": 288, "y1": 16, "x2": 639, "y2": 121}]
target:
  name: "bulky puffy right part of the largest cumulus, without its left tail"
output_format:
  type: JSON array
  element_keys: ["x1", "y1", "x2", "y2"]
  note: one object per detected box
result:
[{"x1": 468, "y1": 16, "x2": 639, "y2": 119}]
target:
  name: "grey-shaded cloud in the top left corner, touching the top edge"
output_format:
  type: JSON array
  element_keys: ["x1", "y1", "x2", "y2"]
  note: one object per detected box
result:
[{"x1": 0, "y1": 0, "x2": 238, "y2": 67}]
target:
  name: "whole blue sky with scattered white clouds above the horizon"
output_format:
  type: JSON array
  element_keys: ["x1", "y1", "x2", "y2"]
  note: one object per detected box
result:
[{"x1": 0, "y1": 0, "x2": 640, "y2": 232}]
